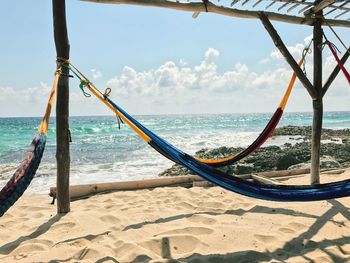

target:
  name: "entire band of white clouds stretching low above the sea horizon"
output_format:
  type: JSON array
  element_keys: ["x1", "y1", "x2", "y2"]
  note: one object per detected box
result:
[{"x1": 0, "y1": 44, "x2": 350, "y2": 116}]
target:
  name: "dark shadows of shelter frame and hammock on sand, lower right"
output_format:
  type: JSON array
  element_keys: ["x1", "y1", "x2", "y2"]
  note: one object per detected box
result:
[{"x1": 124, "y1": 200, "x2": 350, "y2": 263}]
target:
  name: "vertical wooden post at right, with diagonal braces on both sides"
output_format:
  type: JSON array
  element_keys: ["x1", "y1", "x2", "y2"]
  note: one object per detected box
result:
[{"x1": 311, "y1": 11, "x2": 323, "y2": 184}]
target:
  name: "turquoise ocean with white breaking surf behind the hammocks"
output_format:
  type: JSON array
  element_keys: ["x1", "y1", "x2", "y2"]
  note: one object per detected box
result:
[{"x1": 0, "y1": 112, "x2": 350, "y2": 192}]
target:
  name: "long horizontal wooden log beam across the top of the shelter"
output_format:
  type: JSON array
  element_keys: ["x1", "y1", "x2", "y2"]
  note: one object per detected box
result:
[{"x1": 80, "y1": 0, "x2": 350, "y2": 27}]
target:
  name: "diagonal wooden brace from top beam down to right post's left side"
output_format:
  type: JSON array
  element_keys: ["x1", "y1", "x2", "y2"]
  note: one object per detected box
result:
[{"x1": 259, "y1": 12, "x2": 317, "y2": 99}]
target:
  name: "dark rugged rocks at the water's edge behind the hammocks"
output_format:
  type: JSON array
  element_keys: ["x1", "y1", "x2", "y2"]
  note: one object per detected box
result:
[{"x1": 160, "y1": 126, "x2": 350, "y2": 176}]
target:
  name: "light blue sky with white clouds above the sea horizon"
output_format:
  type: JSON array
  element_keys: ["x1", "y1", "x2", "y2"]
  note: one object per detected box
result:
[{"x1": 0, "y1": 0, "x2": 350, "y2": 117}]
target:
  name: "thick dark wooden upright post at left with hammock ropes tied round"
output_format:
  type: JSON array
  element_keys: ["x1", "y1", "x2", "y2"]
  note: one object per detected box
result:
[{"x1": 52, "y1": 0, "x2": 70, "y2": 213}]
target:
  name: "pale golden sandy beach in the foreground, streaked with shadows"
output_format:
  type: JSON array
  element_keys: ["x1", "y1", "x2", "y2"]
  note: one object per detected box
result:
[{"x1": 0, "y1": 170, "x2": 350, "y2": 262}]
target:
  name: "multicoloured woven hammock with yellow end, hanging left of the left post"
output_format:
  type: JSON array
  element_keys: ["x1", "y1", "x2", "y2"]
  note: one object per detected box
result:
[{"x1": 0, "y1": 72, "x2": 59, "y2": 217}]
